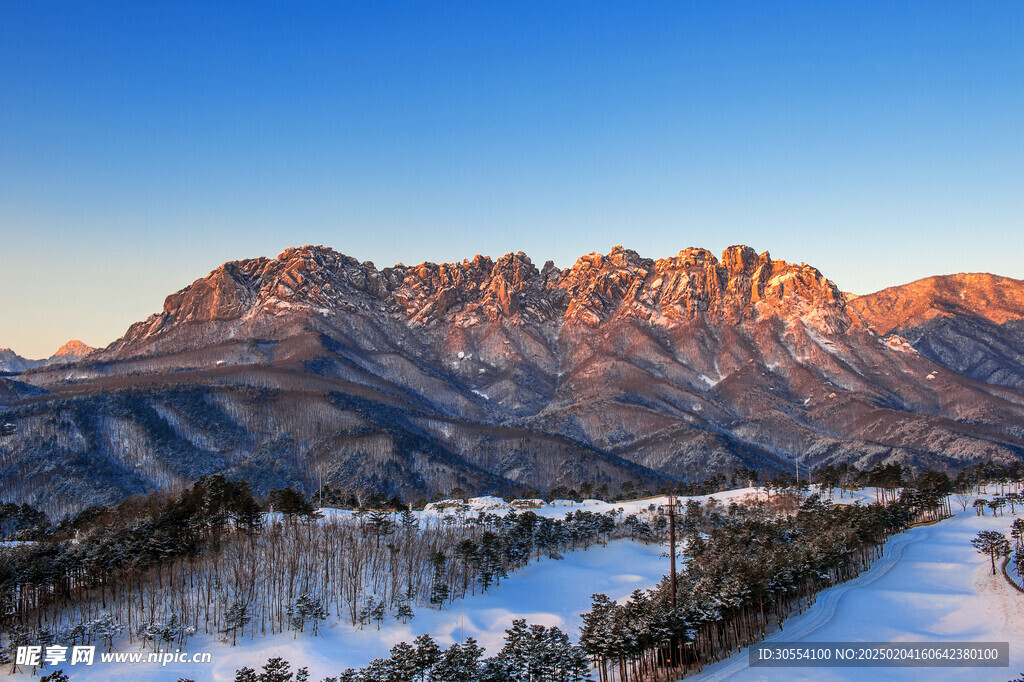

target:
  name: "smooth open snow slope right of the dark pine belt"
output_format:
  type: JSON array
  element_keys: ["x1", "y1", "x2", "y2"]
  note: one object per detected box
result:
[{"x1": 694, "y1": 509, "x2": 1024, "y2": 682}]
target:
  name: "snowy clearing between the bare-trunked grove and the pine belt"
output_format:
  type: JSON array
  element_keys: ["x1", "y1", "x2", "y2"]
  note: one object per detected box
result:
[{"x1": 41, "y1": 541, "x2": 669, "y2": 682}]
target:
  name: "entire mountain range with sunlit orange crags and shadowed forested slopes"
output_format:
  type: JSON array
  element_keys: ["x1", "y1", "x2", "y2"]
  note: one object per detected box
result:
[{"x1": 0, "y1": 246, "x2": 1024, "y2": 512}]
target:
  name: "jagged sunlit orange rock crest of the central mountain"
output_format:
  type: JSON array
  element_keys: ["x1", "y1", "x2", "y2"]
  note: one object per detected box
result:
[{"x1": 99, "y1": 240, "x2": 850, "y2": 348}]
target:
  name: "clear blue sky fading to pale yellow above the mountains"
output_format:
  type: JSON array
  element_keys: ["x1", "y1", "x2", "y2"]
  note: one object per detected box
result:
[{"x1": 0, "y1": 0, "x2": 1024, "y2": 356}]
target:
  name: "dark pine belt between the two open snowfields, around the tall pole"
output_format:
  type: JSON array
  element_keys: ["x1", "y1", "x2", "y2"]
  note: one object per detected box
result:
[{"x1": 580, "y1": 472, "x2": 951, "y2": 682}]
